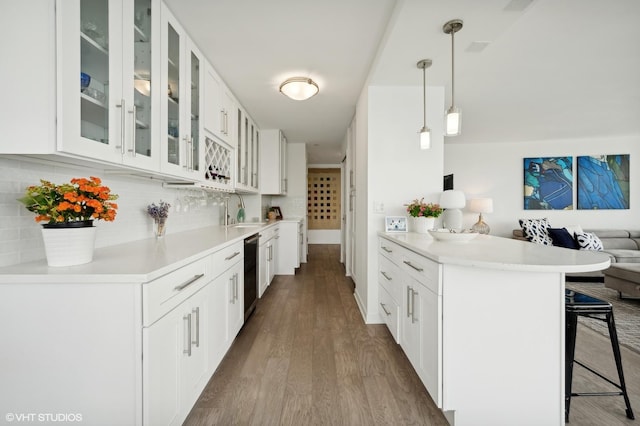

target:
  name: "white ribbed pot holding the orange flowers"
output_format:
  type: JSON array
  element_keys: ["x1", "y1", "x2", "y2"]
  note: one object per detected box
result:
[{"x1": 42, "y1": 226, "x2": 96, "y2": 266}]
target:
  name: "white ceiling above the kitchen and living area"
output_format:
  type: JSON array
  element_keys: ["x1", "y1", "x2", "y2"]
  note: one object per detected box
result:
[{"x1": 165, "y1": 0, "x2": 640, "y2": 163}]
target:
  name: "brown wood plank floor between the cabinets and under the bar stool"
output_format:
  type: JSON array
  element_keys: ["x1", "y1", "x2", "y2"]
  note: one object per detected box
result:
[{"x1": 185, "y1": 245, "x2": 640, "y2": 426}]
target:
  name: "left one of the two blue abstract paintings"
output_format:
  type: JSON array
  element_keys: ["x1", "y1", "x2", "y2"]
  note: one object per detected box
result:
[{"x1": 524, "y1": 157, "x2": 573, "y2": 210}]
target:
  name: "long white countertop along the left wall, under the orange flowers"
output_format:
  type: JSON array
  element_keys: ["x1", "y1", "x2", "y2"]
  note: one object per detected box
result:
[{"x1": 0, "y1": 219, "x2": 299, "y2": 285}]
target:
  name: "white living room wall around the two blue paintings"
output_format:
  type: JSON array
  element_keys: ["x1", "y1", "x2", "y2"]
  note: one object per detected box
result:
[{"x1": 444, "y1": 135, "x2": 640, "y2": 237}]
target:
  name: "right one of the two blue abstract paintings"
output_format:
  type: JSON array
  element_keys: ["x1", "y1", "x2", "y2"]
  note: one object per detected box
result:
[{"x1": 578, "y1": 154, "x2": 630, "y2": 210}]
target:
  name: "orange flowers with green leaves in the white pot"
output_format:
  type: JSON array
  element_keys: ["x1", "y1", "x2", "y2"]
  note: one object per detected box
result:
[{"x1": 18, "y1": 176, "x2": 118, "y2": 224}]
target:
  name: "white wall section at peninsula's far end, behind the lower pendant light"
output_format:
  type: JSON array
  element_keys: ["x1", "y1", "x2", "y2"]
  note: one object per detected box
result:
[{"x1": 354, "y1": 86, "x2": 444, "y2": 323}]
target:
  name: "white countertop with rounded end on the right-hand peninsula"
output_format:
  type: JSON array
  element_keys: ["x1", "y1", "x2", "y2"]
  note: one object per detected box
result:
[{"x1": 378, "y1": 232, "x2": 611, "y2": 272}]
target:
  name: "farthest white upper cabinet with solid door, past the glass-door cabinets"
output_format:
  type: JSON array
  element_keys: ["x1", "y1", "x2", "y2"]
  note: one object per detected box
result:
[{"x1": 260, "y1": 129, "x2": 287, "y2": 195}]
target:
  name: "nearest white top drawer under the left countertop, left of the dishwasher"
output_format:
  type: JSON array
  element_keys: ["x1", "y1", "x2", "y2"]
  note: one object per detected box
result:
[{"x1": 142, "y1": 256, "x2": 213, "y2": 327}]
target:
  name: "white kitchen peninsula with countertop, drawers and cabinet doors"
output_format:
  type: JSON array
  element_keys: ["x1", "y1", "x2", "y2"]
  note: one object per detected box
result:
[{"x1": 378, "y1": 233, "x2": 609, "y2": 426}]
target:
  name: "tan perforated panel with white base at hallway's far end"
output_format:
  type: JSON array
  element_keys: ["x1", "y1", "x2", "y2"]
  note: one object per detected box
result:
[{"x1": 307, "y1": 166, "x2": 342, "y2": 244}]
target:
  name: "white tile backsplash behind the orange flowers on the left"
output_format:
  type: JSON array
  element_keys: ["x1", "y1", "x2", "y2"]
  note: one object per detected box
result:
[{"x1": 0, "y1": 156, "x2": 224, "y2": 267}]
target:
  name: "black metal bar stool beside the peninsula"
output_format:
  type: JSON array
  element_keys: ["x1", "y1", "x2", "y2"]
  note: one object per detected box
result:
[{"x1": 565, "y1": 290, "x2": 635, "y2": 422}]
